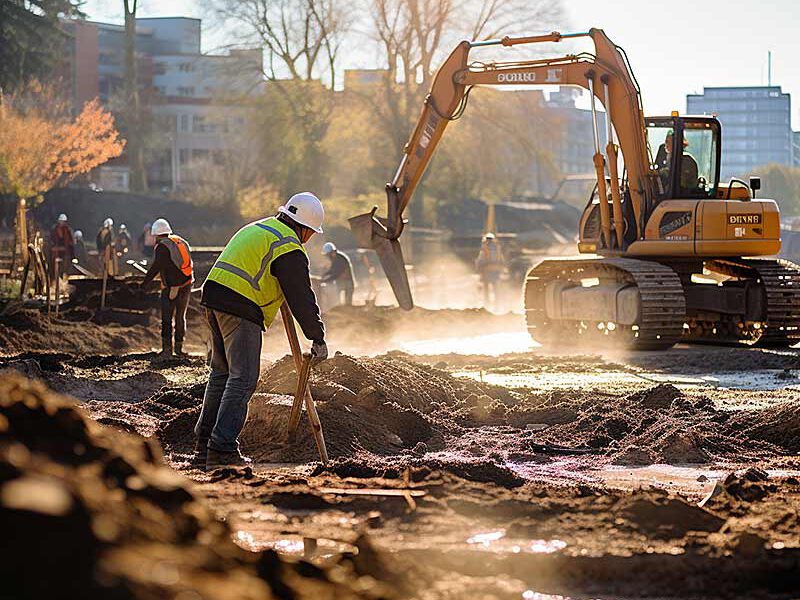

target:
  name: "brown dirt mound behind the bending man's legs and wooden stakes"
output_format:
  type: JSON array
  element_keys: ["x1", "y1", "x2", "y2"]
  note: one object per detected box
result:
[{"x1": 157, "y1": 354, "x2": 513, "y2": 462}]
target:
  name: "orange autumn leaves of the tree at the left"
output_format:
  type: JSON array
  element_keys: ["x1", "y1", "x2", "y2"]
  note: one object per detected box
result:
[{"x1": 0, "y1": 86, "x2": 125, "y2": 198}]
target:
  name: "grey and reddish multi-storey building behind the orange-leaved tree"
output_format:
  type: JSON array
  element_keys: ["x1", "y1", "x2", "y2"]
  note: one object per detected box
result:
[{"x1": 65, "y1": 17, "x2": 264, "y2": 188}]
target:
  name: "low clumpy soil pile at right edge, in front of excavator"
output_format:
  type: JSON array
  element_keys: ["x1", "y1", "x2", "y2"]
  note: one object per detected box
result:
[{"x1": 511, "y1": 384, "x2": 800, "y2": 465}]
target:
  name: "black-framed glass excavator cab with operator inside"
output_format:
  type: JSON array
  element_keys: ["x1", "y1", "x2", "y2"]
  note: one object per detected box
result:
[{"x1": 645, "y1": 115, "x2": 721, "y2": 203}]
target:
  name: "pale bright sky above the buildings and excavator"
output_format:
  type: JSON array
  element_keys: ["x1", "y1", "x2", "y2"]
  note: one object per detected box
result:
[{"x1": 84, "y1": 0, "x2": 800, "y2": 130}]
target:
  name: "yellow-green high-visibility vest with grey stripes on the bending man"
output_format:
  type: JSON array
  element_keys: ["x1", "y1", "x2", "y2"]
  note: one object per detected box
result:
[{"x1": 208, "y1": 217, "x2": 305, "y2": 326}]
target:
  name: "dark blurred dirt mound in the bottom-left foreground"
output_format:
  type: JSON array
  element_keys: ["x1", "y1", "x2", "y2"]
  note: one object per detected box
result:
[{"x1": 0, "y1": 376, "x2": 388, "y2": 600}]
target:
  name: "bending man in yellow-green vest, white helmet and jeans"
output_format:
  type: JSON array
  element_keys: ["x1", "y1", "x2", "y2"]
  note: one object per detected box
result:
[{"x1": 193, "y1": 192, "x2": 328, "y2": 469}]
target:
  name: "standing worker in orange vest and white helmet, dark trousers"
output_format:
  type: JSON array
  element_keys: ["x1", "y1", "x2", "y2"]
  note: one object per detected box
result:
[{"x1": 142, "y1": 219, "x2": 194, "y2": 358}]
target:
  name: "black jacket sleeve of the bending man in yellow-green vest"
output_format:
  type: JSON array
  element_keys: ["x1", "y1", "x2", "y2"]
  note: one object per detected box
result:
[{"x1": 270, "y1": 250, "x2": 325, "y2": 342}]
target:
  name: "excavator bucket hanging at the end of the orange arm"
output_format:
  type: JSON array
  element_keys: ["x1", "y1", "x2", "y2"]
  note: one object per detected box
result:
[{"x1": 349, "y1": 207, "x2": 414, "y2": 310}]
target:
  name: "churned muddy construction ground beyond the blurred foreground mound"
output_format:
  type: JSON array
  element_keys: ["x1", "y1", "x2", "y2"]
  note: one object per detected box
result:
[{"x1": 0, "y1": 307, "x2": 800, "y2": 600}]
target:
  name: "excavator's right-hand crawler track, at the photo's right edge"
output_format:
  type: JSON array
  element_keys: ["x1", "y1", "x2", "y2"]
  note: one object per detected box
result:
[{"x1": 704, "y1": 258, "x2": 800, "y2": 347}]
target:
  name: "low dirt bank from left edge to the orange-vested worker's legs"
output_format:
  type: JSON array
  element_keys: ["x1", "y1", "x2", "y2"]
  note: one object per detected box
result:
[{"x1": 0, "y1": 309, "x2": 159, "y2": 354}]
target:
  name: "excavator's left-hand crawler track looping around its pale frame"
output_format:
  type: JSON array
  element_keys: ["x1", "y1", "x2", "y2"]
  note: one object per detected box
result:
[{"x1": 525, "y1": 258, "x2": 686, "y2": 350}]
